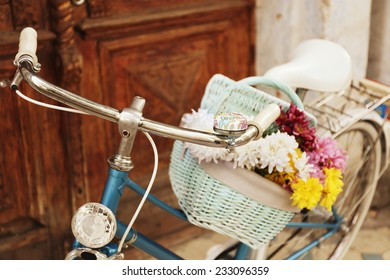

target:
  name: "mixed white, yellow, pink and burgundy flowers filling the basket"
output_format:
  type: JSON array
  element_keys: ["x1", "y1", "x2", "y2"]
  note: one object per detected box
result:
[{"x1": 183, "y1": 103, "x2": 346, "y2": 211}]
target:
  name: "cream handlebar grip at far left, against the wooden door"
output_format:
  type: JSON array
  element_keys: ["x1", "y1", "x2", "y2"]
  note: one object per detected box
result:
[{"x1": 15, "y1": 27, "x2": 38, "y2": 65}]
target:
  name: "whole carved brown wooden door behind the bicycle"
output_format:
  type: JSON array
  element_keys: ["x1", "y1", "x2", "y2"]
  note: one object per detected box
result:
[{"x1": 0, "y1": 0, "x2": 254, "y2": 258}]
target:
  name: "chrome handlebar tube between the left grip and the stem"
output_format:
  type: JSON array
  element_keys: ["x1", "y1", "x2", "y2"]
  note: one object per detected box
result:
[{"x1": 19, "y1": 61, "x2": 120, "y2": 123}]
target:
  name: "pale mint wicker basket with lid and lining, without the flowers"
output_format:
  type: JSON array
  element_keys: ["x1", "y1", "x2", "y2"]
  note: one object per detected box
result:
[{"x1": 169, "y1": 74, "x2": 315, "y2": 248}]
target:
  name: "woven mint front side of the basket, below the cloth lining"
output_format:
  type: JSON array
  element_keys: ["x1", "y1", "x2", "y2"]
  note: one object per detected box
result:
[{"x1": 170, "y1": 142, "x2": 294, "y2": 248}]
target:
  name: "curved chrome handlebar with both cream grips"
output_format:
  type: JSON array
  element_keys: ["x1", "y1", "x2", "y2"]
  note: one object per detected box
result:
[{"x1": 11, "y1": 27, "x2": 280, "y2": 148}]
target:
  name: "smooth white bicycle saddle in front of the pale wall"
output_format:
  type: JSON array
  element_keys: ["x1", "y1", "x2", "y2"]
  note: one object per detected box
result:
[{"x1": 265, "y1": 39, "x2": 352, "y2": 91}]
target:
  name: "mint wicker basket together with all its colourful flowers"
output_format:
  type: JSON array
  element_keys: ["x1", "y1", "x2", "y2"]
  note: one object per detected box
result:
[{"x1": 169, "y1": 74, "x2": 346, "y2": 248}]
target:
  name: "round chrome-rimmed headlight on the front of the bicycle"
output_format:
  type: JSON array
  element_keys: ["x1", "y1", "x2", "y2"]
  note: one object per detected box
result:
[{"x1": 72, "y1": 202, "x2": 116, "y2": 248}]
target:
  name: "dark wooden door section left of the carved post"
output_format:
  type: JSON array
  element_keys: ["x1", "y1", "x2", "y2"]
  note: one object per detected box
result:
[{"x1": 0, "y1": 1, "x2": 71, "y2": 259}]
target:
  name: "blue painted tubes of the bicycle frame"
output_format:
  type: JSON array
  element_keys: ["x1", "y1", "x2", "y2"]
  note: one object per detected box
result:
[{"x1": 74, "y1": 168, "x2": 342, "y2": 260}]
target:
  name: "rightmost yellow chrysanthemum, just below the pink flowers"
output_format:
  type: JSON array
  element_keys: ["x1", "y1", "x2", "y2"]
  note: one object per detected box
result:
[{"x1": 320, "y1": 168, "x2": 344, "y2": 212}]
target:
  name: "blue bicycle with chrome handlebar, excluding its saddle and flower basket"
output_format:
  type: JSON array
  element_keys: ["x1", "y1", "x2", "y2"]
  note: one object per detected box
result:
[{"x1": 11, "y1": 28, "x2": 390, "y2": 259}]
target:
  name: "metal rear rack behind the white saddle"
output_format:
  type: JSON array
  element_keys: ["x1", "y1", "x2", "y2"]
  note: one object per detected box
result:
[{"x1": 305, "y1": 80, "x2": 390, "y2": 137}]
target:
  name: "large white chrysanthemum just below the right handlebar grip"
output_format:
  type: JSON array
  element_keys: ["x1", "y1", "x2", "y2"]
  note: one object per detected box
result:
[{"x1": 259, "y1": 131, "x2": 298, "y2": 174}]
